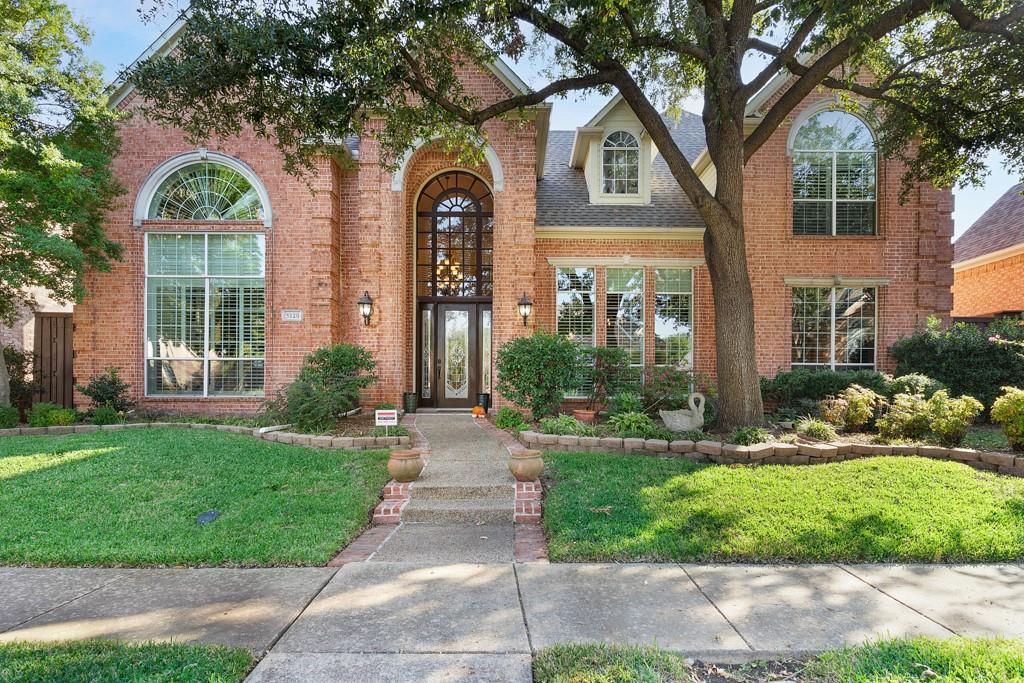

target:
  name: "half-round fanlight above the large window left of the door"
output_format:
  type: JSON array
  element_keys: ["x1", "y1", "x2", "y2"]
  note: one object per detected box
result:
[{"x1": 147, "y1": 162, "x2": 263, "y2": 220}]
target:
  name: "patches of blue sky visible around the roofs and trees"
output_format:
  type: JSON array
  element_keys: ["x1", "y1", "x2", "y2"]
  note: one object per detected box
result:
[{"x1": 66, "y1": 0, "x2": 1017, "y2": 236}]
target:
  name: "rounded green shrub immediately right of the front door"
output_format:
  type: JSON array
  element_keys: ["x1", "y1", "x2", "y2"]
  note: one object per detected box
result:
[{"x1": 497, "y1": 331, "x2": 582, "y2": 420}]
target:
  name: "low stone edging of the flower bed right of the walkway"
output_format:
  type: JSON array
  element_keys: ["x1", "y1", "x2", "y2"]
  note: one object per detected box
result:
[{"x1": 519, "y1": 431, "x2": 1024, "y2": 476}]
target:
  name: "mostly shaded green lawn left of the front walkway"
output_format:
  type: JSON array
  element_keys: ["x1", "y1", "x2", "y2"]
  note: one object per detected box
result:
[{"x1": 0, "y1": 429, "x2": 388, "y2": 565}]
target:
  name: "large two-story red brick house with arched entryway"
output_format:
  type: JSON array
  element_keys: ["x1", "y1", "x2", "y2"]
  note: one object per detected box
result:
[{"x1": 75, "y1": 21, "x2": 952, "y2": 412}]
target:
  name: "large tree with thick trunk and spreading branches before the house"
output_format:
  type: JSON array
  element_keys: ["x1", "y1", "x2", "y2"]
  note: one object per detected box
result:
[{"x1": 135, "y1": 0, "x2": 1024, "y2": 427}]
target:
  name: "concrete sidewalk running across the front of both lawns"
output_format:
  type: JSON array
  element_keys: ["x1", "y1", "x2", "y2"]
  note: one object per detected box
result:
[{"x1": 0, "y1": 562, "x2": 1024, "y2": 681}]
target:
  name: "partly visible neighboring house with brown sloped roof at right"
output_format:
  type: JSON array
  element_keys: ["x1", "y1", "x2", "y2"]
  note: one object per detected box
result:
[{"x1": 953, "y1": 183, "x2": 1024, "y2": 318}]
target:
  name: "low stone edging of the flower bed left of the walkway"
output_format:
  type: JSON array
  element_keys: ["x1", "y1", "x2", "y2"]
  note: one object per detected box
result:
[{"x1": 0, "y1": 422, "x2": 412, "y2": 450}]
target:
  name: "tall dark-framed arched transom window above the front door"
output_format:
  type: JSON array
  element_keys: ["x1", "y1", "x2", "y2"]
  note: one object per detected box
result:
[{"x1": 416, "y1": 171, "x2": 495, "y2": 297}]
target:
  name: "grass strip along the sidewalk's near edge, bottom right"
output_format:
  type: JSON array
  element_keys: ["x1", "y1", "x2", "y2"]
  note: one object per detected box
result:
[{"x1": 534, "y1": 638, "x2": 1024, "y2": 683}]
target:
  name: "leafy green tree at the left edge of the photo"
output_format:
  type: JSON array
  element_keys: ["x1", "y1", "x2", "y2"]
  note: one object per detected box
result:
[{"x1": 0, "y1": 0, "x2": 121, "y2": 405}]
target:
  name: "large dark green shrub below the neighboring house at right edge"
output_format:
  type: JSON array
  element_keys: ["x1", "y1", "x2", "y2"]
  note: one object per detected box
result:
[{"x1": 892, "y1": 319, "x2": 1024, "y2": 407}]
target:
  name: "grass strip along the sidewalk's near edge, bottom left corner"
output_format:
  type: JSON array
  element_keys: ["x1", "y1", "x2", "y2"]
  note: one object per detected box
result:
[{"x1": 0, "y1": 640, "x2": 255, "y2": 683}]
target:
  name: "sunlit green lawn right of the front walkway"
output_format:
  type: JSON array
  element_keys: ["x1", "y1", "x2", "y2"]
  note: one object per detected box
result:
[{"x1": 544, "y1": 453, "x2": 1024, "y2": 562}]
